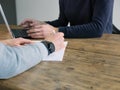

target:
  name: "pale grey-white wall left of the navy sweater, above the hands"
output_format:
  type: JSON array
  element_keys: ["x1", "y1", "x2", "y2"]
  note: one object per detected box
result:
[{"x1": 16, "y1": 0, "x2": 59, "y2": 24}]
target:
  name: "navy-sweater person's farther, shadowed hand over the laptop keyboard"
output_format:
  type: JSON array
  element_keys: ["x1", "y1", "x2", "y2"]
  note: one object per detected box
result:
[{"x1": 20, "y1": 19, "x2": 46, "y2": 29}]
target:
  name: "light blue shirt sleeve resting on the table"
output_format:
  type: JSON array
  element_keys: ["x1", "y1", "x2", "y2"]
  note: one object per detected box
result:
[{"x1": 0, "y1": 42, "x2": 48, "y2": 79}]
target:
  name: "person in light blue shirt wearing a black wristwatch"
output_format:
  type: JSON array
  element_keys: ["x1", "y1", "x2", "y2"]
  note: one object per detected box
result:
[{"x1": 0, "y1": 33, "x2": 64, "y2": 79}]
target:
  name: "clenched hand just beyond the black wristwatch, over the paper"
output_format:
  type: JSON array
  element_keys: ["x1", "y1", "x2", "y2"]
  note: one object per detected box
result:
[{"x1": 45, "y1": 33, "x2": 65, "y2": 51}]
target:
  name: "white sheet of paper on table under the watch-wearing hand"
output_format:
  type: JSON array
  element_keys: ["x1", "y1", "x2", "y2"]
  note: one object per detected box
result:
[{"x1": 43, "y1": 41, "x2": 68, "y2": 61}]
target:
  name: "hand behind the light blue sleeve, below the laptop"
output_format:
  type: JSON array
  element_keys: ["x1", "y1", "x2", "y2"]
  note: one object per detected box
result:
[{"x1": 1, "y1": 38, "x2": 33, "y2": 46}]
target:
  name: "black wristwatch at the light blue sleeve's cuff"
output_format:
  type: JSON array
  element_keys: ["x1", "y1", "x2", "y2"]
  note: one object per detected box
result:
[{"x1": 41, "y1": 40, "x2": 55, "y2": 55}]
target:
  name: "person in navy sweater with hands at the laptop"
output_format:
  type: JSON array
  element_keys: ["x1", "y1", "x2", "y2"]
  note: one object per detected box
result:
[{"x1": 20, "y1": 0, "x2": 114, "y2": 38}]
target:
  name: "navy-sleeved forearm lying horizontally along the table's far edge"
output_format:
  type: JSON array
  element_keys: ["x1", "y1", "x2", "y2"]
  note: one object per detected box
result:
[{"x1": 58, "y1": 23, "x2": 104, "y2": 38}]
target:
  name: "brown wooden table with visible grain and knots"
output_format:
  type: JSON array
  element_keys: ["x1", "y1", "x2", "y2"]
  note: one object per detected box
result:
[{"x1": 0, "y1": 24, "x2": 120, "y2": 90}]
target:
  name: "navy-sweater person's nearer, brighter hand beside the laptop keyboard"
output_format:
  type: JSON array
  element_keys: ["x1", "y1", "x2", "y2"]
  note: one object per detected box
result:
[{"x1": 27, "y1": 24, "x2": 58, "y2": 38}]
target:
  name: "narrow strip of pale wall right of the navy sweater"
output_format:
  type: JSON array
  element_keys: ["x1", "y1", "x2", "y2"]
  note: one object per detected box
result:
[{"x1": 113, "y1": 0, "x2": 120, "y2": 29}]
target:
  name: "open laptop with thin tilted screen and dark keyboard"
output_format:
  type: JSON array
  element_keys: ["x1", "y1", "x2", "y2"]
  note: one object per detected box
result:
[{"x1": 0, "y1": 4, "x2": 31, "y2": 38}]
